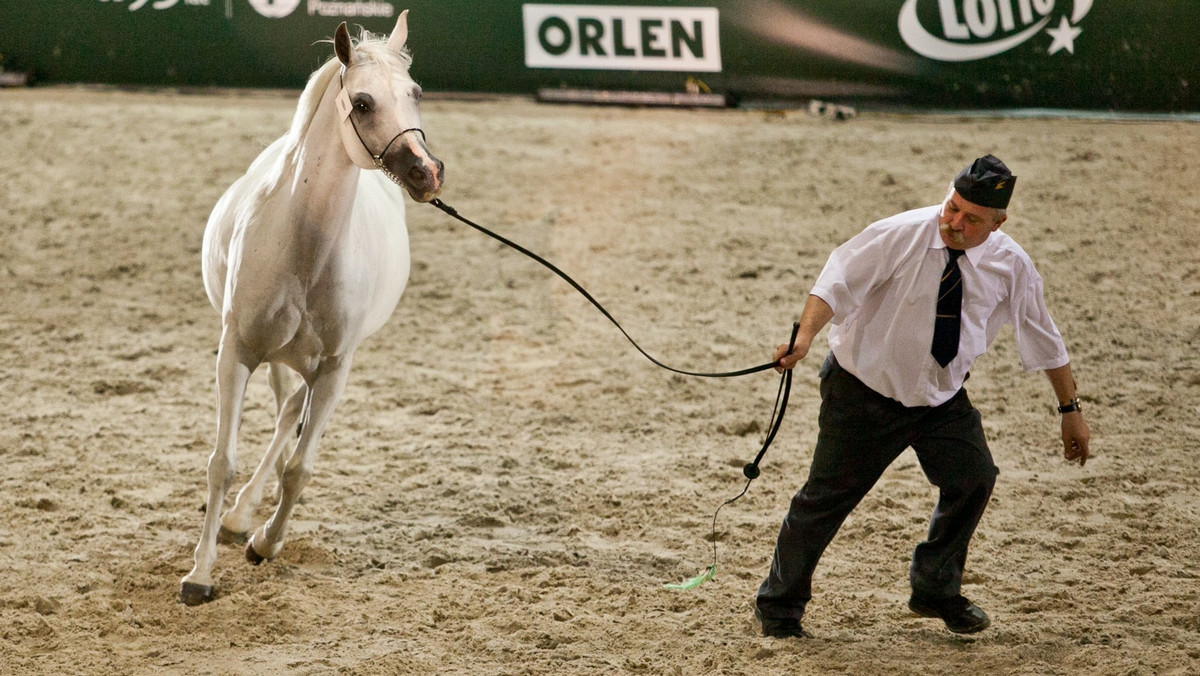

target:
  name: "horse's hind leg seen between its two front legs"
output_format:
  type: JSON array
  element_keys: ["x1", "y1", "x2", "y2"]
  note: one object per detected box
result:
[{"x1": 217, "y1": 364, "x2": 308, "y2": 544}]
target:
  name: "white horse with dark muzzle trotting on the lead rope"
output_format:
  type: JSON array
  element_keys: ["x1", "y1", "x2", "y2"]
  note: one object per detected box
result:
[{"x1": 179, "y1": 11, "x2": 443, "y2": 605}]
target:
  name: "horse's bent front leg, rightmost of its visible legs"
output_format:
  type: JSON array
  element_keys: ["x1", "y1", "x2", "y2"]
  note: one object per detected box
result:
[{"x1": 246, "y1": 357, "x2": 350, "y2": 564}]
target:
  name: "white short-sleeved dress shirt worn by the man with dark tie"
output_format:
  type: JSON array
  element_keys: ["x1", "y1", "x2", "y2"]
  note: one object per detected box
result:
[{"x1": 811, "y1": 204, "x2": 1068, "y2": 406}]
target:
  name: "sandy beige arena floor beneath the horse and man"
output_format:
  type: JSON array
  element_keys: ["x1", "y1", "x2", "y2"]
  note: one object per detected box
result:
[{"x1": 0, "y1": 88, "x2": 1200, "y2": 676}]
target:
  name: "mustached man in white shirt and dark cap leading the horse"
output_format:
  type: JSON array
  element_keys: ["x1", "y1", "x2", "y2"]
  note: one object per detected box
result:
[{"x1": 755, "y1": 155, "x2": 1091, "y2": 638}]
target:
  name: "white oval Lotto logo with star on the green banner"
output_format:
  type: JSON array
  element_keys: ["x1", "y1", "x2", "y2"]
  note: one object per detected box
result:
[{"x1": 899, "y1": 0, "x2": 1092, "y2": 61}]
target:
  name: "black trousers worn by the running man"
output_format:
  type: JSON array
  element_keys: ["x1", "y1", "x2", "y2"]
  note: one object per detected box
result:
[{"x1": 756, "y1": 354, "x2": 997, "y2": 620}]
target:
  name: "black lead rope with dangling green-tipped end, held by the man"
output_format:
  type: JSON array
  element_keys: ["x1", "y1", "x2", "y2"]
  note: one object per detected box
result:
[{"x1": 430, "y1": 198, "x2": 800, "y2": 588}]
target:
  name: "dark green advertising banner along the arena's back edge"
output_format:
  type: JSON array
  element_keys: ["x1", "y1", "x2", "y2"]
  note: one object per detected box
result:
[{"x1": 0, "y1": 0, "x2": 1200, "y2": 112}]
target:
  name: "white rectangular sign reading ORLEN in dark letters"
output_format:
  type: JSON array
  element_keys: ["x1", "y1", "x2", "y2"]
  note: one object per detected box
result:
[{"x1": 522, "y1": 5, "x2": 721, "y2": 72}]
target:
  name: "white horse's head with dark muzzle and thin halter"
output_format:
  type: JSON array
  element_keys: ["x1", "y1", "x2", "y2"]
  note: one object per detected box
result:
[{"x1": 334, "y1": 10, "x2": 443, "y2": 202}]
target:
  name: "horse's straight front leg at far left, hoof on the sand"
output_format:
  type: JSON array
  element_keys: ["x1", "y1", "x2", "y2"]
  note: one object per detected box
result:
[{"x1": 179, "y1": 338, "x2": 253, "y2": 605}]
